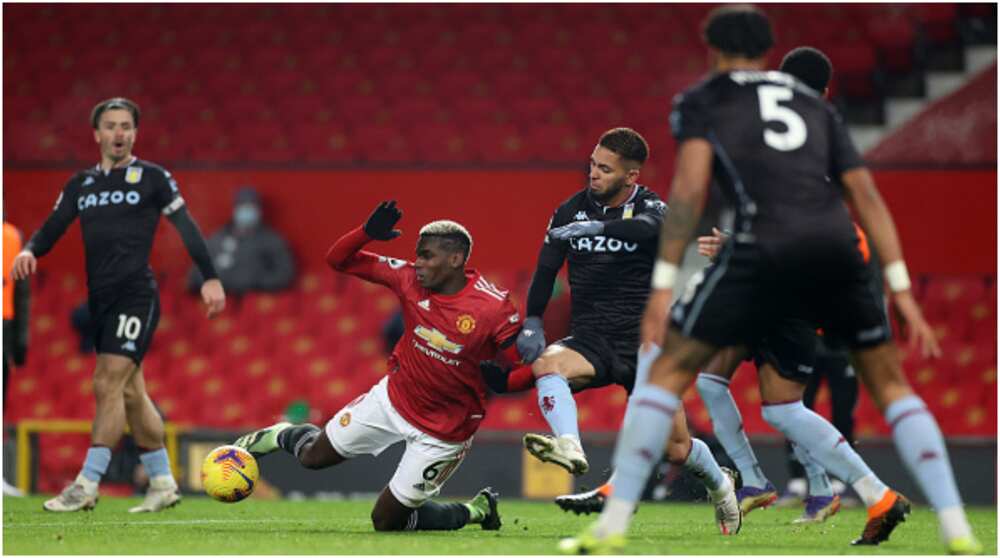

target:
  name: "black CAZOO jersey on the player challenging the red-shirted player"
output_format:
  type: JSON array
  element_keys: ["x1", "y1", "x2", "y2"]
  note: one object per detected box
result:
[{"x1": 545, "y1": 186, "x2": 667, "y2": 343}]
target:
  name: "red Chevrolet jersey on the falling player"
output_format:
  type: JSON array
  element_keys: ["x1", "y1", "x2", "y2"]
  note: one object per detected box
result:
[{"x1": 327, "y1": 227, "x2": 521, "y2": 442}]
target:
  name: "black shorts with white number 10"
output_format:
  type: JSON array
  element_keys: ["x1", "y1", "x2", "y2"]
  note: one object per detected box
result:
[{"x1": 88, "y1": 281, "x2": 160, "y2": 364}]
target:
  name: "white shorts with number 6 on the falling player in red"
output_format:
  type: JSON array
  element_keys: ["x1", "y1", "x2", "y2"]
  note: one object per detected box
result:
[{"x1": 326, "y1": 376, "x2": 472, "y2": 508}]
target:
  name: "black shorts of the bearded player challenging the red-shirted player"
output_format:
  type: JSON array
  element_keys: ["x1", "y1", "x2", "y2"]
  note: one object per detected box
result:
[{"x1": 554, "y1": 330, "x2": 639, "y2": 395}]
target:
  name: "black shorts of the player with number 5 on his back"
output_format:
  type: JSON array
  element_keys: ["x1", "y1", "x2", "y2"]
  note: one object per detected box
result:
[{"x1": 670, "y1": 242, "x2": 891, "y2": 349}]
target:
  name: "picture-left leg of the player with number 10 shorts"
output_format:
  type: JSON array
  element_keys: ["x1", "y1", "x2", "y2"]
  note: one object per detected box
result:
[{"x1": 43, "y1": 353, "x2": 136, "y2": 512}]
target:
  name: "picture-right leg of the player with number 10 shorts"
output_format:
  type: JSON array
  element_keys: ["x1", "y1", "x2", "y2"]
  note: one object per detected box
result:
[{"x1": 125, "y1": 367, "x2": 181, "y2": 513}]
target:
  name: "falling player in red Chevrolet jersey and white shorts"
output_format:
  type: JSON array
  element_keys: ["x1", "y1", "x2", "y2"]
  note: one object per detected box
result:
[{"x1": 236, "y1": 202, "x2": 521, "y2": 531}]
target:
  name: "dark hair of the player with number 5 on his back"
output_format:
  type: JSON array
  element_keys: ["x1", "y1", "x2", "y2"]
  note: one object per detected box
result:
[{"x1": 702, "y1": 4, "x2": 774, "y2": 59}]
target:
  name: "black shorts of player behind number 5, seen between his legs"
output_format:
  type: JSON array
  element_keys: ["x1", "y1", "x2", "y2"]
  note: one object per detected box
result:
[{"x1": 750, "y1": 319, "x2": 820, "y2": 384}]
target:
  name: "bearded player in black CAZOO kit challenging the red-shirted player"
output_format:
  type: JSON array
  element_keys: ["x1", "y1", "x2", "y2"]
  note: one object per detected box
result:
[{"x1": 484, "y1": 128, "x2": 742, "y2": 534}]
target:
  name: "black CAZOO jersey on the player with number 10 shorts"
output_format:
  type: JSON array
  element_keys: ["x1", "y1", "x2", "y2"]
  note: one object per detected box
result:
[{"x1": 31, "y1": 158, "x2": 184, "y2": 293}]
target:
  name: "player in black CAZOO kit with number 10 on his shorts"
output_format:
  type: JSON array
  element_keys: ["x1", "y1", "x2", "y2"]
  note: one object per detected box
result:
[{"x1": 13, "y1": 97, "x2": 226, "y2": 513}]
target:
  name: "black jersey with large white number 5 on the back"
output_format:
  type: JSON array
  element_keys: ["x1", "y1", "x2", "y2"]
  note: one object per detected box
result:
[{"x1": 670, "y1": 71, "x2": 863, "y2": 272}]
